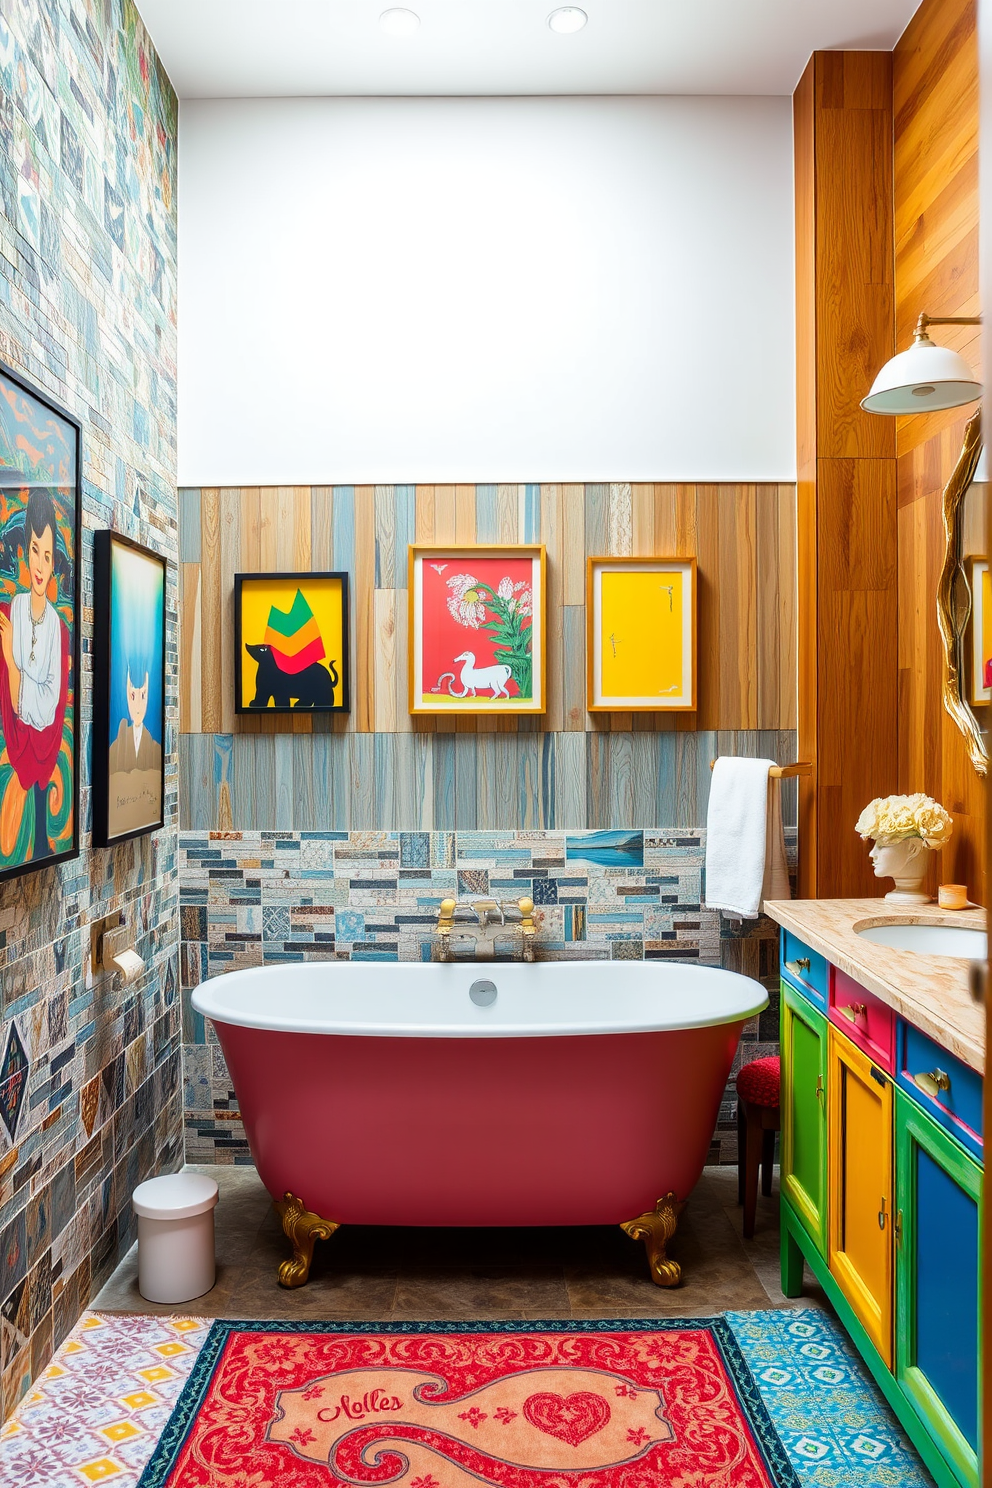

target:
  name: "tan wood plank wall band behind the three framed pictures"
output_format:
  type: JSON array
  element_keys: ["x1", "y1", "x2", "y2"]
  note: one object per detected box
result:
[{"x1": 180, "y1": 484, "x2": 796, "y2": 737}]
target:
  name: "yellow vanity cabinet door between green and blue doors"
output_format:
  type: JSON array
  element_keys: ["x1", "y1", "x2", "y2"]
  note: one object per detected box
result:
[{"x1": 827, "y1": 1028, "x2": 892, "y2": 1367}]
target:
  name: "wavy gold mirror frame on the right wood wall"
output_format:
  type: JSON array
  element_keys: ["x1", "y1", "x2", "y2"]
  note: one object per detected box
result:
[{"x1": 937, "y1": 414, "x2": 989, "y2": 775}]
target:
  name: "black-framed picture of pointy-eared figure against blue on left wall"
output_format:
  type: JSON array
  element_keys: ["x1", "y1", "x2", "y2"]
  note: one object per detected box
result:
[{"x1": 92, "y1": 531, "x2": 168, "y2": 847}]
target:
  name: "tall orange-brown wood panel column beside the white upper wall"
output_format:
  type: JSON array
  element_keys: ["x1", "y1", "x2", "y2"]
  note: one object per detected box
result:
[{"x1": 793, "y1": 52, "x2": 898, "y2": 899}]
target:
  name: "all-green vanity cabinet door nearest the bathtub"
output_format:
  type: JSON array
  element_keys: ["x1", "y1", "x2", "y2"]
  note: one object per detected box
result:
[{"x1": 781, "y1": 982, "x2": 828, "y2": 1256}]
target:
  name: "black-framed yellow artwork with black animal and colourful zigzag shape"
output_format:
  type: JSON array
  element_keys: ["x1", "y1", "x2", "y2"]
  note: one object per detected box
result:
[{"x1": 233, "y1": 573, "x2": 351, "y2": 714}]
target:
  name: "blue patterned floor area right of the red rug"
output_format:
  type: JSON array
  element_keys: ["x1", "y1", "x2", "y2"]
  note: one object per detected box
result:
[{"x1": 727, "y1": 1308, "x2": 933, "y2": 1488}]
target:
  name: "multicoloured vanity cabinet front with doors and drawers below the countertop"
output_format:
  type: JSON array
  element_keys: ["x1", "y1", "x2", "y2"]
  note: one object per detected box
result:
[{"x1": 781, "y1": 934, "x2": 983, "y2": 1488}]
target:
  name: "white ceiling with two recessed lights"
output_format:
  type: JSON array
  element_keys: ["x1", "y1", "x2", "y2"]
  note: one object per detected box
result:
[{"x1": 137, "y1": 0, "x2": 919, "y2": 98}]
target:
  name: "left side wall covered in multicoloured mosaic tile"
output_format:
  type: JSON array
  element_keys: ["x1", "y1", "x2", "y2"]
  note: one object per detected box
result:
[{"x1": 0, "y1": 0, "x2": 181, "y2": 1415}]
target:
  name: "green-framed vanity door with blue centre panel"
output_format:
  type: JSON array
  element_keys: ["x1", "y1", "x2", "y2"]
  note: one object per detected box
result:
[{"x1": 895, "y1": 1091, "x2": 982, "y2": 1488}]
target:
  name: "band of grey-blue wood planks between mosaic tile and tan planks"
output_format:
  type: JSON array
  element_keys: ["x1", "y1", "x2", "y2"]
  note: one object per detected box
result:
[{"x1": 178, "y1": 729, "x2": 796, "y2": 832}]
